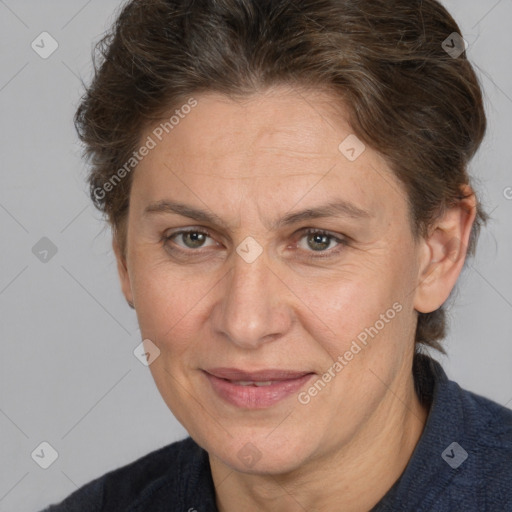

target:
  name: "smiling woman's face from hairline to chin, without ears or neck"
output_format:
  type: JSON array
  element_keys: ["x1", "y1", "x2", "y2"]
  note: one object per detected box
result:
[{"x1": 116, "y1": 88, "x2": 424, "y2": 472}]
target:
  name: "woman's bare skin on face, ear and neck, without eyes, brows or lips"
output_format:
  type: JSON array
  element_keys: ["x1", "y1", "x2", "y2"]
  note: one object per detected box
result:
[{"x1": 114, "y1": 87, "x2": 475, "y2": 512}]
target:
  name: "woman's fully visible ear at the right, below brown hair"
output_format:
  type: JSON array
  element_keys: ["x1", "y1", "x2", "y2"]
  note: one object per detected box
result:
[{"x1": 414, "y1": 185, "x2": 477, "y2": 313}]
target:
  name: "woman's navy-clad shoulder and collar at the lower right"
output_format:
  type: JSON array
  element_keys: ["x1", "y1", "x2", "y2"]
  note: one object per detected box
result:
[{"x1": 375, "y1": 357, "x2": 512, "y2": 512}]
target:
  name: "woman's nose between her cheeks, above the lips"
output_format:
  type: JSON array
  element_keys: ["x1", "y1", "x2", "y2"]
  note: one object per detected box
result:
[{"x1": 211, "y1": 247, "x2": 293, "y2": 349}]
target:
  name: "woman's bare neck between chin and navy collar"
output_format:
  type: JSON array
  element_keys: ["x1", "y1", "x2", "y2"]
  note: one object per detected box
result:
[{"x1": 210, "y1": 364, "x2": 428, "y2": 512}]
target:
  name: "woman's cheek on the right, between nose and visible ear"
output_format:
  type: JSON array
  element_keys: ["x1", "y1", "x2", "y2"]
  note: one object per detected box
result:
[{"x1": 294, "y1": 265, "x2": 413, "y2": 368}]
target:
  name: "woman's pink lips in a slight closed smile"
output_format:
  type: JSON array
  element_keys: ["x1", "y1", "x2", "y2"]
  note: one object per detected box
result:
[{"x1": 203, "y1": 368, "x2": 314, "y2": 409}]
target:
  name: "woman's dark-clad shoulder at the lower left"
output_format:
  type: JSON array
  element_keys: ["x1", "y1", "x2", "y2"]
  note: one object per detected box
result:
[{"x1": 43, "y1": 437, "x2": 205, "y2": 512}]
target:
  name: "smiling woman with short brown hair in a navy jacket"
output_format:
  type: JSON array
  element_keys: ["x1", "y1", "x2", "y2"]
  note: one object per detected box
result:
[{"x1": 44, "y1": 0, "x2": 512, "y2": 512}]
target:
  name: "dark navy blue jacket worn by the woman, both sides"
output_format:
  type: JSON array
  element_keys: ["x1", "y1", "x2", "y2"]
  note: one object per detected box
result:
[{"x1": 43, "y1": 354, "x2": 512, "y2": 512}]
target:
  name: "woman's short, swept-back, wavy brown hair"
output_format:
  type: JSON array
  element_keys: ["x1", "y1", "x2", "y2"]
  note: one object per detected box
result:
[{"x1": 75, "y1": 0, "x2": 487, "y2": 352}]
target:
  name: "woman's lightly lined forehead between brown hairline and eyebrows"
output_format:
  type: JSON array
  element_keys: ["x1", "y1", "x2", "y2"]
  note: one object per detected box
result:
[{"x1": 134, "y1": 87, "x2": 405, "y2": 228}]
